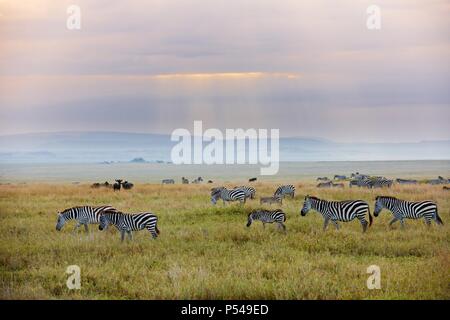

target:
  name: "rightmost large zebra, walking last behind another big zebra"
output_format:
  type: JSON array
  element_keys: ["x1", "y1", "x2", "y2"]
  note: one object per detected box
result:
[{"x1": 373, "y1": 196, "x2": 444, "y2": 228}]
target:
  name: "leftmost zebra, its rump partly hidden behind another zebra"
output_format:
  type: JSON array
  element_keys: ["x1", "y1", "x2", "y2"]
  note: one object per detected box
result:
[{"x1": 56, "y1": 206, "x2": 116, "y2": 232}]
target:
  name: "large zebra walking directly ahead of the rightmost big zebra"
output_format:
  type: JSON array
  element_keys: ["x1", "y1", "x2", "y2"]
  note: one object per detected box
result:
[{"x1": 300, "y1": 196, "x2": 372, "y2": 232}]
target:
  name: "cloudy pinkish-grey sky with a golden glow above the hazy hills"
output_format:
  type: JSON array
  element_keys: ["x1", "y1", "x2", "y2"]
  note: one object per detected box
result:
[{"x1": 0, "y1": 0, "x2": 450, "y2": 142}]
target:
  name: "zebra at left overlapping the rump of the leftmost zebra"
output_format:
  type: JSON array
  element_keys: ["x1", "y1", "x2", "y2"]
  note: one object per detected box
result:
[{"x1": 98, "y1": 210, "x2": 160, "y2": 241}]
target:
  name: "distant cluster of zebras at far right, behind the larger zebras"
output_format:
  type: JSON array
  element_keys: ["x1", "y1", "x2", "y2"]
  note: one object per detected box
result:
[{"x1": 316, "y1": 172, "x2": 450, "y2": 190}]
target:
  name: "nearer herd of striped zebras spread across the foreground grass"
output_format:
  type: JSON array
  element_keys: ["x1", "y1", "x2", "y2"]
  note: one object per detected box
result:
[{"x1": 56, "y1": 181, "x2": 443, "y2": 241}]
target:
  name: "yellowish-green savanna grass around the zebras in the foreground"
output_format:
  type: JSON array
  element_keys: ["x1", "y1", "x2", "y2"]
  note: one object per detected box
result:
[{"x1": 0, "y1": 181, "x2": 450, "y2": 299}]
